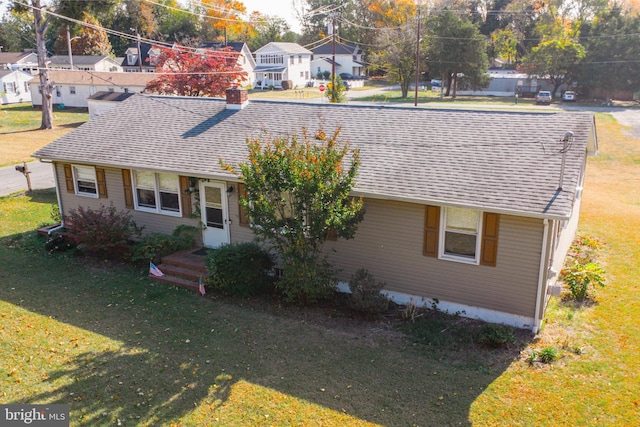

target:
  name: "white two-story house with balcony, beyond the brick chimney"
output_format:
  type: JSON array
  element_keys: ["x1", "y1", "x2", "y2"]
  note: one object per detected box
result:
[{"x1": 255, "y1": 42, "x2": 313, "y2": 88}]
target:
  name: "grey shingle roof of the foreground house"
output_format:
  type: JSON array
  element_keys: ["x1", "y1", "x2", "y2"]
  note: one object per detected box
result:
[{"x1": 34, "y1": 94, "x2": 595, "y2": 218}]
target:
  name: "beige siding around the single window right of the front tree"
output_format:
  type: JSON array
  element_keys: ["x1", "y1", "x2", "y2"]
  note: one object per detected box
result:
[{"x1": 326, "y1": 199, "x2": 543, "y2": 317}]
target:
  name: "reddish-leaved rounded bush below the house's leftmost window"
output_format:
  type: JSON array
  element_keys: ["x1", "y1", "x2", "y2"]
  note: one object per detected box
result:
[{"x1": 65, "y1": 205, "x2": 142, "y2": 258}]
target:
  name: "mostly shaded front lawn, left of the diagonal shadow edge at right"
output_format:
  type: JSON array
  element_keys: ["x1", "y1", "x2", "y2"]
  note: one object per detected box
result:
[{"x1": 0, "y1": 192, "x2": 518, "y2": 426}]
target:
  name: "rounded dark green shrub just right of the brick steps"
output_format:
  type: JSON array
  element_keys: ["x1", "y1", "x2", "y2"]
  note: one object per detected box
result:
[{"x1": 207, "y1": 243, "x2": 273, "y2": 297}]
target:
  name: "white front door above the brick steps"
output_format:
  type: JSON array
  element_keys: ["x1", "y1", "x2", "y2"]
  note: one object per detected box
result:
[{"x1": 200, "y1": 182, "x2": 229, "y2": 248}]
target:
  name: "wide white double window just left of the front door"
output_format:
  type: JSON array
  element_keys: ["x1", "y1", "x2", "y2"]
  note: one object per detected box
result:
[{"x1": 134, "y1": 171, "x2": 180, "y2": 216}]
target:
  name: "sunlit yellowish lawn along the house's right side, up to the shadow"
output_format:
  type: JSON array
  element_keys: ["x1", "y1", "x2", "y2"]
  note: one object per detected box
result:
[{"x1": 469, "y1": 114, "x2": 640, "y2": 426}]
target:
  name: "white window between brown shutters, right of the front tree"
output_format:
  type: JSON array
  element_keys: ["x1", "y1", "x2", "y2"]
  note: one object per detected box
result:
[{"x1": 440, "y1": 208, "x2": 482, "y2": 264}]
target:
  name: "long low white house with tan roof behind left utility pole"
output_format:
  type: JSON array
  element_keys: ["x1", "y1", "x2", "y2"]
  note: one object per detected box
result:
[{"x1": 29, "y1": 70, "x2": 157, "y2": 107}]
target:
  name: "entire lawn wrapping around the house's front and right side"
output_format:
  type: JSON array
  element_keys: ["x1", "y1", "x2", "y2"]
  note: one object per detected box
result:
[{"x1": 0, "y1": 115, "x2": 640, "y2": 426}]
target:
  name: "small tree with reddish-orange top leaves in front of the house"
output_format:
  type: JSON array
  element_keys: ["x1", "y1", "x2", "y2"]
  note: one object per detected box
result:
[{"x1": 223, "y1": 129, "x2": 364, "y2": 303}]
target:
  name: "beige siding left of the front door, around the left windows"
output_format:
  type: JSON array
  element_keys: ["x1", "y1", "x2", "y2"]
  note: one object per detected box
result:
[{"x1": 56, "y1": 163, "x2": 202, "y2": 245}]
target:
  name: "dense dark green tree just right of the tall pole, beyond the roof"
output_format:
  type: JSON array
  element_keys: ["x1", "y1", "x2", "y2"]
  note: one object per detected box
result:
[{"x1": 427, "y1": 10, "x2": 489, "y2": 97}]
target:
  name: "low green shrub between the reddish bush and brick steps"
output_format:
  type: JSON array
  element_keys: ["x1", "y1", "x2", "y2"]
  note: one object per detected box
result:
[{"x1": 131, "y1": 226, "x2": 197, "y2": 263}]
